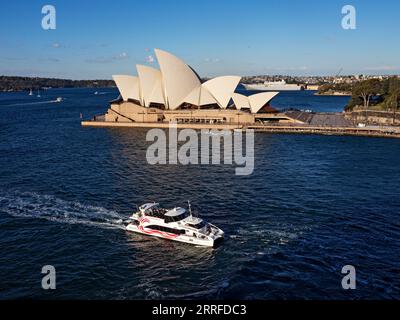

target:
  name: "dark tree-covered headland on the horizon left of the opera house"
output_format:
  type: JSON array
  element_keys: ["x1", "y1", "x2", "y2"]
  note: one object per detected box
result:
[{"x1": 0, "y1": 76, "x2": 115, "y2": 91}]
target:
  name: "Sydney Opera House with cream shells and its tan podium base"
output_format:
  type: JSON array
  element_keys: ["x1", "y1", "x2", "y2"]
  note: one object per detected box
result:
[{"x1": 95, "y1": 49, "x2": 292, "y2": 124}]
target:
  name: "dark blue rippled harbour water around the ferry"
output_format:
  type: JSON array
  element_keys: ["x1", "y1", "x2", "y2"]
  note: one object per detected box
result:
[{"x1": 0, "y1": 89, "x2": 400, "y2": 299}]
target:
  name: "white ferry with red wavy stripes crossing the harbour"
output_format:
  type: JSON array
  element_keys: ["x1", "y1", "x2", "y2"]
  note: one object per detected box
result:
[{"x1": 125, "y1": 202, "x2": 224, "y2": 247}]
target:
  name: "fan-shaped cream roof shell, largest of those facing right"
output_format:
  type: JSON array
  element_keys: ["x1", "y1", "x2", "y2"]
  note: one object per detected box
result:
[{"x1": 203, "y1": 76, "x2": 241, "y2": 109}]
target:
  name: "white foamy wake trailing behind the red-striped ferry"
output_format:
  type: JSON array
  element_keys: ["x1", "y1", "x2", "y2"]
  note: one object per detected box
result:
[{"x1": 0, "y1": 192, "x2": 126, "y2": 229}]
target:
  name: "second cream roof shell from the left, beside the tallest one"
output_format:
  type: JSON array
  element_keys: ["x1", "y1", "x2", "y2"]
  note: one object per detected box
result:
[{"x1": 136, "y1": 65, "x2": 166, "y2": 107}]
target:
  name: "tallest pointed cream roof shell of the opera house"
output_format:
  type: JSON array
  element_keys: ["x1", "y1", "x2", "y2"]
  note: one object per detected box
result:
[{"x1": 154, "y1": 49, "x2": 201, "y2": 110}]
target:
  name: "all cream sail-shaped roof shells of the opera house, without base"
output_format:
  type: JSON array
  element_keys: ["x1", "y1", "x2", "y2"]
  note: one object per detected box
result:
[{"x1": 113, "y1": 49, "x2": 278, "y2": 113}]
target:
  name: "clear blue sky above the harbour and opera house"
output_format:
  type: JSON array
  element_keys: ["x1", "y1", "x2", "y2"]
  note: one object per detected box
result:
[{"x1": 0, "y1": 0, "x2": 400, "y2": 79}]
